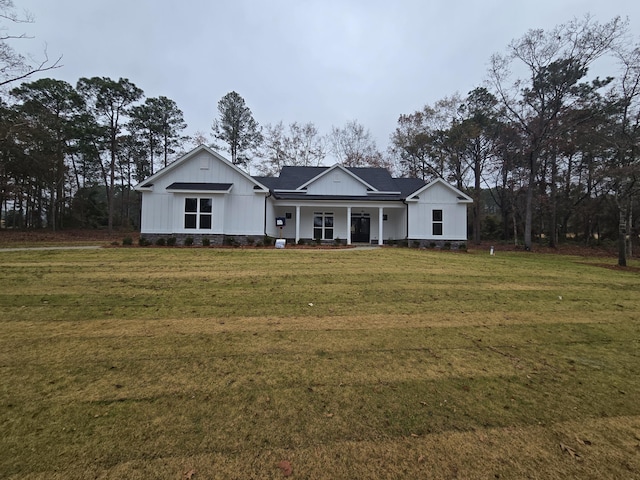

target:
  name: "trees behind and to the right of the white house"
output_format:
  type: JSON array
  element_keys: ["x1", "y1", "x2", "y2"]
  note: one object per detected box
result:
[{"x1": 209, "y1": 15, "x2": 640, "y2": 265}]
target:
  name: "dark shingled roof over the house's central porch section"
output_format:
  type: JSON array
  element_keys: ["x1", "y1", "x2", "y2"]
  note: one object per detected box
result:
[{"x1": 253, "y1": 166, "x2": 426, "y2": 201}]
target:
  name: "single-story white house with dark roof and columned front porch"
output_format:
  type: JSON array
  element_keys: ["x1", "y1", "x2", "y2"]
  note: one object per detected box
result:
[{"x1": 135, "y1": 145, "x2": 472, "y2": 246}]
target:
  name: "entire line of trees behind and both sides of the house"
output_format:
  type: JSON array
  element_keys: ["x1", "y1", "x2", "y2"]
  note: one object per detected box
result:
[{"x1": 0, "y1": 0, "x2": 640, "y2": 265}]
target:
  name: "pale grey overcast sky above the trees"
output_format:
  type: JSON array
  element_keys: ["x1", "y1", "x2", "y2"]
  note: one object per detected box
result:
[{"x1": 12, "y1": 0, "x2": 640, "y2": 158}]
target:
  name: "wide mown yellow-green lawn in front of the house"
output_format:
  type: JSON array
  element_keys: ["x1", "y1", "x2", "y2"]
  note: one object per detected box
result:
[{"x1": 0, "y1": 248, "x2": 640, "y2": 479}]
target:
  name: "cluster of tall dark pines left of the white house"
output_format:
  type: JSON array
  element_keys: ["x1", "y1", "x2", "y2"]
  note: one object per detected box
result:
[{"x1": 0, "y1": 77, "x2": 186, "y2": 231}]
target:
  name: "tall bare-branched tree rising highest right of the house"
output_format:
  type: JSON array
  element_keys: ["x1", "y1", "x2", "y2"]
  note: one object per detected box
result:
[{"x1": 489, "y1": 16, "x2": 627, "y2": 250}]
